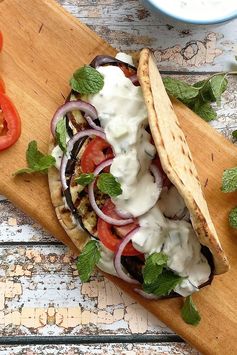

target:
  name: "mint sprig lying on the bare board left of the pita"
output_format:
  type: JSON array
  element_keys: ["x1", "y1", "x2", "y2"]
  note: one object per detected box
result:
[{"x1": 13, "y1": 141, "x2": 56, "y2": 175}]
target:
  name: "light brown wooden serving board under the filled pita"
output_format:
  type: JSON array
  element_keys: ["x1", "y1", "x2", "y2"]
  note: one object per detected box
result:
[{"x1": 0, "y1": 0, "x2": 237, "y2": 355}]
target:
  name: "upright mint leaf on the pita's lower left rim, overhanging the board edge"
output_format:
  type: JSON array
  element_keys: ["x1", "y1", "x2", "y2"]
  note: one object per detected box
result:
[{"x1": 76, "y1": 240, "x2": 100, "y2": 282}]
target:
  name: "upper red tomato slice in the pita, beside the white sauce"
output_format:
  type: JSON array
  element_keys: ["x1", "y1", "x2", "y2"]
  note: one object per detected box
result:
[{"x1": 81, "y1": 137, "x2": 113, "y2": 173}]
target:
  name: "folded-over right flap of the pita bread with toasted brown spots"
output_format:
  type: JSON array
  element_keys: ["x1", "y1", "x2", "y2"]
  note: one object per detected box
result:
[{"x1": 138, "y1": 49, "x2": 229, "y2": 274}]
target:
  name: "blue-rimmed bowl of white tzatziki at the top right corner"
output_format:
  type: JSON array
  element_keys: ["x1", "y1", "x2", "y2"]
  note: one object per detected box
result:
[{"x1": 143, "y1": 0, "x2": 237, "y2": 25}]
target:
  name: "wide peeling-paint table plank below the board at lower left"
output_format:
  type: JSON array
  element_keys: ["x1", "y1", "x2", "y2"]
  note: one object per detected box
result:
[{"x1": 0, "y1": 245, "x2": 172, "y2": 336}]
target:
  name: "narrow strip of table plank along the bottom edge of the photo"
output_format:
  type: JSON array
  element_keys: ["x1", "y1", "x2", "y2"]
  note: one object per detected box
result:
[{"x1": 0, "y1": 343, "x2": 199, "y2": 355}]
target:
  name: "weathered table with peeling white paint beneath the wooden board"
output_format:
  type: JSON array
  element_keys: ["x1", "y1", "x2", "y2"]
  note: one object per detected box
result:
[{"x1": 0, "y1": 0, "x2": 237, "y2": 355}]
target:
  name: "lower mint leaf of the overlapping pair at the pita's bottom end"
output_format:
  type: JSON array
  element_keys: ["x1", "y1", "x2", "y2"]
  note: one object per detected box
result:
[{"x1": 143, "y1": 270, "x2": 183, "y2": 297}]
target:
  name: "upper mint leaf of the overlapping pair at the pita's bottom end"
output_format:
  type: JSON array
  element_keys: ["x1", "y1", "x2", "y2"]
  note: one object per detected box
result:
[{"x1": 142, "y1": 253, "x2": 168, "y2": 284}]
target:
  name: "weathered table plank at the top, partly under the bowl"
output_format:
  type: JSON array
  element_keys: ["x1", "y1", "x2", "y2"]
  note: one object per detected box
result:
[{"x1": 57, "y1": 0, "x2": 237, "y2": 71}]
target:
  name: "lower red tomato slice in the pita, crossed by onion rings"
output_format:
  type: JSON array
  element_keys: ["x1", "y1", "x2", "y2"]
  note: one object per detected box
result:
[{"x1": 97, "y1": 200, "x2": 141, "y2": 256}]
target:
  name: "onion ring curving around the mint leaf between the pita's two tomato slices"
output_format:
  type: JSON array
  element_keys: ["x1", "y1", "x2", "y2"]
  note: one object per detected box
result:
[{"x1": 88, "y1": 159, "x2": 133, "y2": 226}]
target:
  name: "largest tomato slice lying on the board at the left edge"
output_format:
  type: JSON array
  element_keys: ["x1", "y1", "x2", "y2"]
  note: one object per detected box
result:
[{"x1": 0, "y1": 93, "x2": 21, "y2": 151}]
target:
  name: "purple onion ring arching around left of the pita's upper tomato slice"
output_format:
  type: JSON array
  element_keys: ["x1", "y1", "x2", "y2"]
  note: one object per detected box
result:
[{"x1": 60, "y1": 129, "x2": 105, "y2": 191}]
